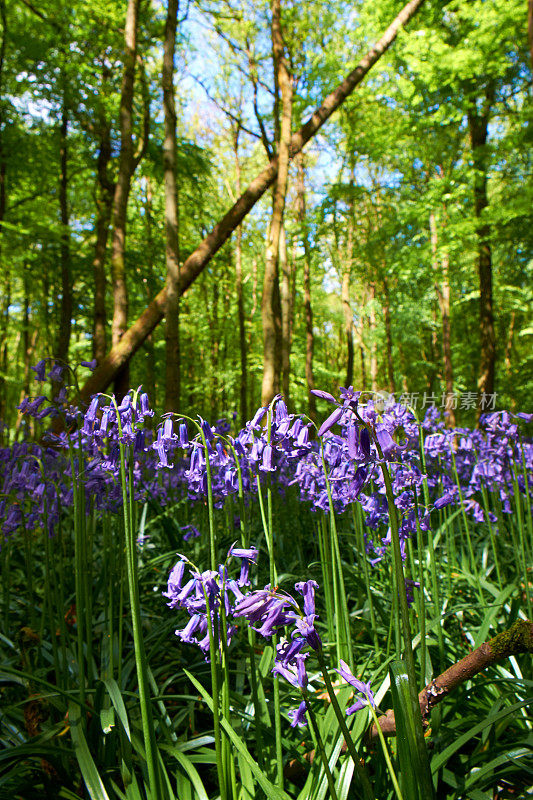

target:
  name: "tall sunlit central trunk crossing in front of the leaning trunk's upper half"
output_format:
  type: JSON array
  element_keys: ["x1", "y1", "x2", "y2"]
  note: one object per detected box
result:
[{"x1": 261, "y1": 0, "x2": 292, "y2": 405}]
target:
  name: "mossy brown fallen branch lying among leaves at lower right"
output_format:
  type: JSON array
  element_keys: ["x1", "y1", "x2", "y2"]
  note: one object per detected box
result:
[{"x1": 366, "y1": 620, "x2": 533, "y2": 742}]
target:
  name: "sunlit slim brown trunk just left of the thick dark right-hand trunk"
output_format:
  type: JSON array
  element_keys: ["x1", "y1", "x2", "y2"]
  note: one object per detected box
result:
[{"x1": 429, "y1": 212, "x2": 456, "y2": 428}]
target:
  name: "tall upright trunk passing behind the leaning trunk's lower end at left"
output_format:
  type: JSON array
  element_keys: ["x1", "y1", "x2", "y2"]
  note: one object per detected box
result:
[{"x1": 111, "y1": 0, "x2": 138, "y2": 398}]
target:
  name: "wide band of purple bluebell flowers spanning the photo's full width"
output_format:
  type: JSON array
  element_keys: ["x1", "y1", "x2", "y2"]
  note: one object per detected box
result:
[{"x1": 0, "y1": 362, "x2": 533, "y2": 562}]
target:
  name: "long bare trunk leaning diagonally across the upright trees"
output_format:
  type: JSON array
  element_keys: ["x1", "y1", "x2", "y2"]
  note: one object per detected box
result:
[{"x1": 81, "y1": 0, "x2": 424, "y2": 400}]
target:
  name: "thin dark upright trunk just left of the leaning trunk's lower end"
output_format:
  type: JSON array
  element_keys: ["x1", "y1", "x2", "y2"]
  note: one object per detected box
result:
[{"x1": 55, "y1": 92, "x2": 72, "y2": 382}]
